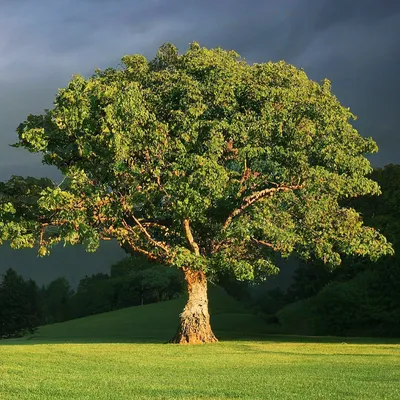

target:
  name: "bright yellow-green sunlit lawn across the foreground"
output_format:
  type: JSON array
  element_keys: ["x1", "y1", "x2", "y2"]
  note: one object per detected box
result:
[{"x1": 0, "y1": 341, "x2": 400, "y2": 400}]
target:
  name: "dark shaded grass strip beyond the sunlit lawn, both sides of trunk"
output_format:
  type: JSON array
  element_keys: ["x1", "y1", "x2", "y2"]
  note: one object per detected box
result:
[{"x1": 0, "y1": 301, "x2": 400, "y2": 346}]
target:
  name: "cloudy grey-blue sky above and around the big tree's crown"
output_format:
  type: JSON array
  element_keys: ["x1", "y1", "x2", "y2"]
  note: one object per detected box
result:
[{"x1": 0, "y1": 0, "x2": 400, "y2": 284}]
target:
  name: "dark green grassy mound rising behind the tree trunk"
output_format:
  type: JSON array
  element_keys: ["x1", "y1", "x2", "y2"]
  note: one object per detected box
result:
[{"x1": 31, "y1": 285, "x2": 267, "y2": 342}]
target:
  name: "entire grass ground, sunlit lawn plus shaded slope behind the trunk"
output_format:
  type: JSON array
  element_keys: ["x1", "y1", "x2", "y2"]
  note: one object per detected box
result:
[{"x1": 0, "y1": 289, "x2": 400, "y2": 400}]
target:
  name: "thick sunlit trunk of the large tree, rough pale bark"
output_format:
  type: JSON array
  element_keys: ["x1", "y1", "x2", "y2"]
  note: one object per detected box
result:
[{"x1": 171, "y1": 268, "x2": 218, "y2": 344}]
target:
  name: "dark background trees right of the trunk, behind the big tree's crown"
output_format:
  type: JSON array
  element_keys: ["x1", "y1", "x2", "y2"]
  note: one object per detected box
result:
[{"x1": 234, "y1": 165, "x2": 400, "y2": 336}]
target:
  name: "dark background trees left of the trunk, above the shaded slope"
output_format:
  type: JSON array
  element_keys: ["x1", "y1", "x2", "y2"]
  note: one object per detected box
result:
[{"x1": 0, "y1": 257, "x2": 183, "y2": 338}]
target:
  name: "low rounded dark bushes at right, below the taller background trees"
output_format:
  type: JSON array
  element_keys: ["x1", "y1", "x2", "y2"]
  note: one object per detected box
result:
[{"x1": 278, "y1": 263, "x2": 400, "y2": 336}]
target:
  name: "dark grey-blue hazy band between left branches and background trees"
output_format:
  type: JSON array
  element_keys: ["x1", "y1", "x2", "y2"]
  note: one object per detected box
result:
[{"x1": 0, "y1": 242, "x2": 126, "y2": 287}]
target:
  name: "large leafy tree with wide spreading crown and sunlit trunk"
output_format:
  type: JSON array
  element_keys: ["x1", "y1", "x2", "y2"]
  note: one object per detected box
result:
[{"x1": 0, "y1": 43, "x2": 392, "y2": 343}]
